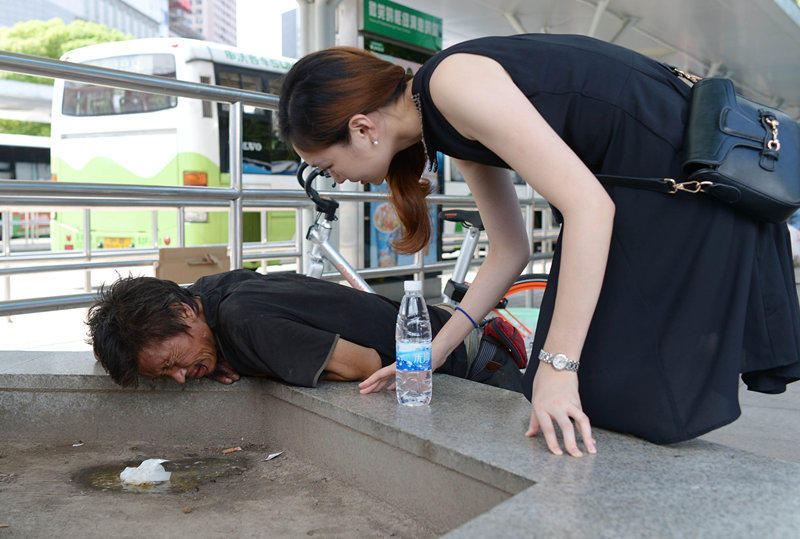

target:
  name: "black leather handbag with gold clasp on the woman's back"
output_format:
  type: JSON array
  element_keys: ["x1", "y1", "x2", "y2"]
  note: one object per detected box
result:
[{"x1": 598, "y1": 68, "x2": 800, "y2": 223}]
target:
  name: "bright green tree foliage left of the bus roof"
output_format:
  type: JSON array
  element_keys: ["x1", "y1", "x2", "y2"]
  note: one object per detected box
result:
[{"x1": 0, "y1": 18, "x2": 133, "y2": 84}]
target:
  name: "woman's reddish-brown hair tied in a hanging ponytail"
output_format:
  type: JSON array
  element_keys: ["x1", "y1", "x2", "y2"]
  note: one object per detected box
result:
[{"x1": 278, "y1": 47, "x2": 431, "y2": 253}]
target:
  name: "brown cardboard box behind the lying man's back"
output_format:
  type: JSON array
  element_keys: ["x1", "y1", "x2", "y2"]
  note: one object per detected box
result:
[{"x1": 155, "y1": 245, "x2": 231, "y2": 284}]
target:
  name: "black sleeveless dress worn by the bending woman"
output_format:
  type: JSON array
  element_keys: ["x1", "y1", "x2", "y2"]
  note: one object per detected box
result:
[{"x1": 412, "y1": 34, "x2": 800, "y2": 443}]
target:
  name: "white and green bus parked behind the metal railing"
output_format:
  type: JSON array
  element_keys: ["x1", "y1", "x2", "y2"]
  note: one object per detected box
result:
[{"x1": 51, "y1": 38, "x2": 299, "y2": 250}]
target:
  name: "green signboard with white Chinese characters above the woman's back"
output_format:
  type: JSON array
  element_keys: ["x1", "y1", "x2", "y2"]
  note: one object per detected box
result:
[{"x1": 364, "y1": 0, "x2": 442, "y2": 51}]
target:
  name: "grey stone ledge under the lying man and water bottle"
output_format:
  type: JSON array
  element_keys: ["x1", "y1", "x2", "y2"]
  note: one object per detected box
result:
[{"x1": 0, "y1": 352, "x2": 800, "y2": 537}]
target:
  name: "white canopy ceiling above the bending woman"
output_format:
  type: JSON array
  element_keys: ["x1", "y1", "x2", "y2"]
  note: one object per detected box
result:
[{"x1": 399, "y1": 0, "x2": 800, "y2": 117}]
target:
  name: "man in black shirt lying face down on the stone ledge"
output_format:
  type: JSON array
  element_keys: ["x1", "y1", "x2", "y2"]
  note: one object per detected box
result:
[{"x1": 87, "y1": 269, "x2": 527, "y2": 392}]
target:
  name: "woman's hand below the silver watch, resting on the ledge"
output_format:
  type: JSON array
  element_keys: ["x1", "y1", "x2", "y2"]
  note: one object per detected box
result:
[{"x1": 525, "y1": 363, "x2": 597, "y2": 457}]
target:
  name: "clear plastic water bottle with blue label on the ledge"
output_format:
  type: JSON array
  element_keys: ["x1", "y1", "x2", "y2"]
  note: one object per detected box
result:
[{"x1": 395, "y1": 281, "x2": 433, "y2": 406}]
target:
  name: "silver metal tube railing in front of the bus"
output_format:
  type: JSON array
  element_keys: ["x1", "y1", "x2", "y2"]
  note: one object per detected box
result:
[{"x1": 0, "y1": 47, "x2": 553, "y2": 316}]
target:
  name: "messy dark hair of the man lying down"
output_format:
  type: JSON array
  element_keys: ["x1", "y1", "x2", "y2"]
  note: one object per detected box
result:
[{"x1": 86, "y1": 277, "x2": 199, "y2": 387}]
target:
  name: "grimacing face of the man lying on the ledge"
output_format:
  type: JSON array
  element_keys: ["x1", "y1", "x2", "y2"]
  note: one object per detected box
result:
[{"x1": 137, "y1": 305, "x2": 217, "y2": 384}]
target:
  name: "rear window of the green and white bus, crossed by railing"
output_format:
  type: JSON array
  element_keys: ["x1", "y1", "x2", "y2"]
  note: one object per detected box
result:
[{"x1": 61, "y1": 54, "x2": 178, "y2": 116}]
